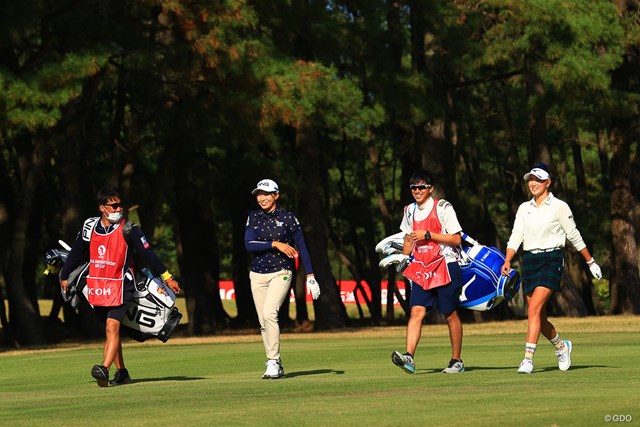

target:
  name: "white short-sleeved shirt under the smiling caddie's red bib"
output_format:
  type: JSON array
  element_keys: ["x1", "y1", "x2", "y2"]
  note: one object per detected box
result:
[{"x1": 400, "y1": 197, "x2": 462, "y2": 262}]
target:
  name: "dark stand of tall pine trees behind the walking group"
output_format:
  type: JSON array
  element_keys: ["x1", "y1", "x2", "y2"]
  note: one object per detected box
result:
[{"x1": 0, "y1": 0, "x2": 640, "y2": 345}]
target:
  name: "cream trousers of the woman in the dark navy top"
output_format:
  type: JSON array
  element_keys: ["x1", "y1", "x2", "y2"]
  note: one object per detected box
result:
[{"x1": 249, "y1": 270, "x2": 292, "y2": 360}]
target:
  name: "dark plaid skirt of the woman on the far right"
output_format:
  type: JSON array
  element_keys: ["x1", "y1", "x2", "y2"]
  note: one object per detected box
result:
[{"x1": 522, "y1": 249, "x2": 564, "y2": 295}]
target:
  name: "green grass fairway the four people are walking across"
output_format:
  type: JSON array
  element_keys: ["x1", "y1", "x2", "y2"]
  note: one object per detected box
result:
[{"x1": 0, "y1": 317, "x2": 640, "y2": 426}]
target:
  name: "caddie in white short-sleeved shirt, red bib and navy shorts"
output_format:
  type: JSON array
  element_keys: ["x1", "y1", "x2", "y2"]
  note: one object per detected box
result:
[{"x1": 391, "y1": 171, "x2": 464, "y2": 374}]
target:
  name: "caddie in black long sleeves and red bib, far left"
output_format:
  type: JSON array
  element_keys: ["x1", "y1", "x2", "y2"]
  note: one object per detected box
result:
[{"x1": 60, "y1": 185, "x2": 180, "y2": 387}]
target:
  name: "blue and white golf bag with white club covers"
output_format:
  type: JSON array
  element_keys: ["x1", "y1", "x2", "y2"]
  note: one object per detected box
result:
[{"x1": 376, "y1": 232, "x2": 521, "y2": 311}]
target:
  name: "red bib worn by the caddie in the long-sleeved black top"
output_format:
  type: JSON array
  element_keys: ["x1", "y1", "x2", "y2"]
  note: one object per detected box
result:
[{"x1": 87, "y1": 219, "x2": 128, "y2": 307}]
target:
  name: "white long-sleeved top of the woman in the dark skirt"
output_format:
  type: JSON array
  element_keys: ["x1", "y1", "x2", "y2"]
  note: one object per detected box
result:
[{"x1": 507, "y1": 193, "x2": 587, "y2": 252}]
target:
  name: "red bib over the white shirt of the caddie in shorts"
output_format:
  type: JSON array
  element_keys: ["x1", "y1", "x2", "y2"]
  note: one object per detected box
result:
[{"x1": 402, "y1": 199, "x2": 451, "y2": 290}]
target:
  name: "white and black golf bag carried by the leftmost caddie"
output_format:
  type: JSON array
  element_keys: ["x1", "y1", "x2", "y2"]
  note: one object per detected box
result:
[{"x1": 45, "y1": 241, "x2": 182, "y2": 342}]
